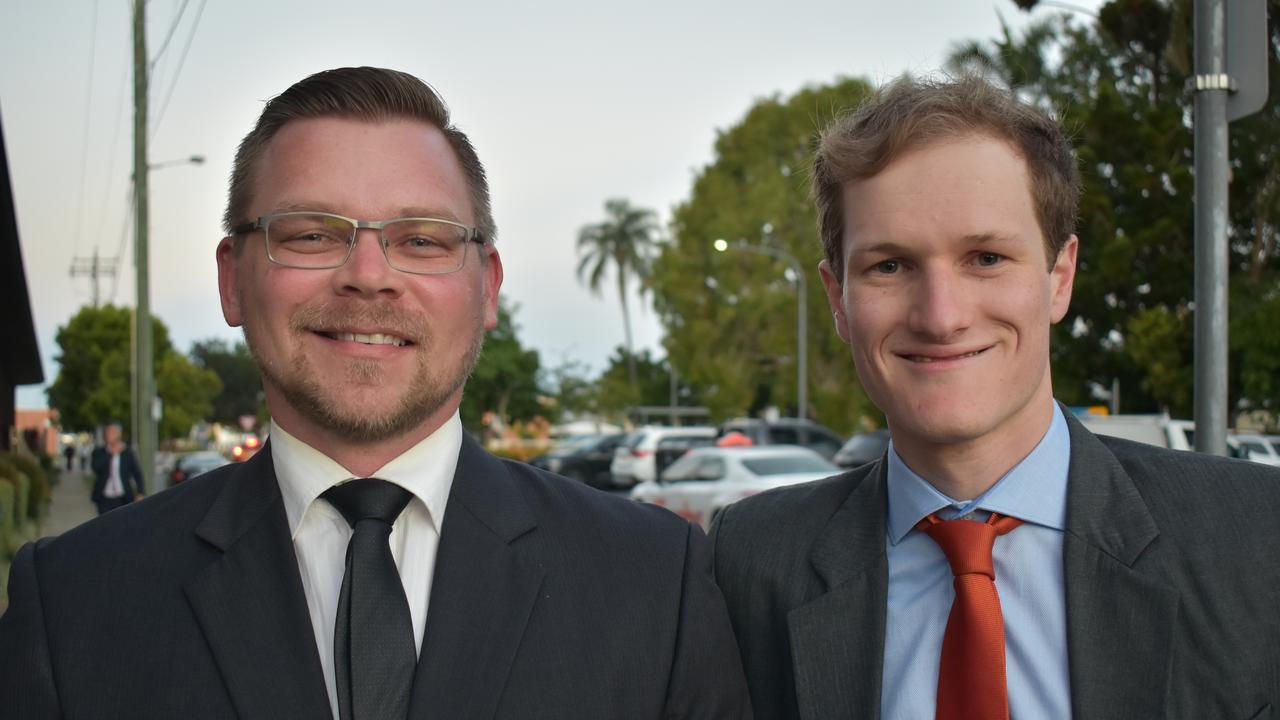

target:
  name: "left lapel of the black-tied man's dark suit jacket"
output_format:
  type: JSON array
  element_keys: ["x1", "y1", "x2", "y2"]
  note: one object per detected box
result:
[{"x1": 183, "y1": 446, "x2": 332, "y2": 717}]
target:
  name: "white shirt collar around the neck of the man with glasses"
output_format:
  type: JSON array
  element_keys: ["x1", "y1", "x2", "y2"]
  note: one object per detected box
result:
[{"x1": 270, "y1": 411, "x2": 462, "y2": 537}]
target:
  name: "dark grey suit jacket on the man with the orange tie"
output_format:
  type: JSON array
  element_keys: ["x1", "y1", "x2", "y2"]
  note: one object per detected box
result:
[{"x1": 712, "y1": 414, "x2": 1280, "y2": 720}]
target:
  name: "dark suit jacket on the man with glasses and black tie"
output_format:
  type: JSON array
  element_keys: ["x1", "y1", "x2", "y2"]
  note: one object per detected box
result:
[{"x1": 0, "y1": 438, "x2": 750, "y2": 720}]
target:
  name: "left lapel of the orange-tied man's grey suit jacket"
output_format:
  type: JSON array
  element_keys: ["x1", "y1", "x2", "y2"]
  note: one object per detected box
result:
[{"x1": 787, "y1": 460, "x2": 888, "y2": 720}]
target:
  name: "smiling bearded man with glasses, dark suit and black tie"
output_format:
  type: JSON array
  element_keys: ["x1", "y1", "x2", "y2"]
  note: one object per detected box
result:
[{"x1": 0, "y1": 68, "x2": 750, "y2": 720}]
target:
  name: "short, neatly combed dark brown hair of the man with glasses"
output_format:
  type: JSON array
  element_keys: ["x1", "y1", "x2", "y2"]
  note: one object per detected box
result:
[{"x1": 223, "y1": 68, "x2": 498, "y2": 242}]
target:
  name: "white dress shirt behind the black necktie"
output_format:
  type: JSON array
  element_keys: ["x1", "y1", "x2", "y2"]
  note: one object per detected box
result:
[{"x1": 271, "y1": 413, "x2": 462, "y2": 717}]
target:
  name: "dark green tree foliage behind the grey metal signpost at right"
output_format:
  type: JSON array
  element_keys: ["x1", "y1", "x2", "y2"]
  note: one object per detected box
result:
[{"x1": 951, "y1": 0, "x2": 1280, "y2": 416}]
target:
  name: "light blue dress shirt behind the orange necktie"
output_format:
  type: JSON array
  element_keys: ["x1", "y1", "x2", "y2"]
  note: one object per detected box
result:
[{"x1": 881, "y1": 402, "x2": 1071, "y2": 720}]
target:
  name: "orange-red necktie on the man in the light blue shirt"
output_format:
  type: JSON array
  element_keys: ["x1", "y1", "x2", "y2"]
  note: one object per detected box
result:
[{"x1": 915, "y1": 512, "x2": 1023, "y2": 720}]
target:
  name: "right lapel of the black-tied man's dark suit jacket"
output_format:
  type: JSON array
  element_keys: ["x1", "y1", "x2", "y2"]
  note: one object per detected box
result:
[{"x1": 410, "y1": 436, "x2": 544, "y2": 717}]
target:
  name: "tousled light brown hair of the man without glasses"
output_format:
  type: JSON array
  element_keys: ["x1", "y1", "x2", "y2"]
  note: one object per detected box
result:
[{"x1": 812, "y1": 76, "x2": 1080, "y2": 279}]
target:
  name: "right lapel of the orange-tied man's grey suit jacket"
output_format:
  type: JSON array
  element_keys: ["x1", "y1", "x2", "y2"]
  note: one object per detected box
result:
[{"x1": 1062, "y1": 413, "x2": 1179, "y2": 720}]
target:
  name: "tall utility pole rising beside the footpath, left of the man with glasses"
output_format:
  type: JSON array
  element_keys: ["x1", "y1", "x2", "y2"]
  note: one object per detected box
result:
[{"x1": 133, "y1": 0, "x2": 156, "y2": 492}]
